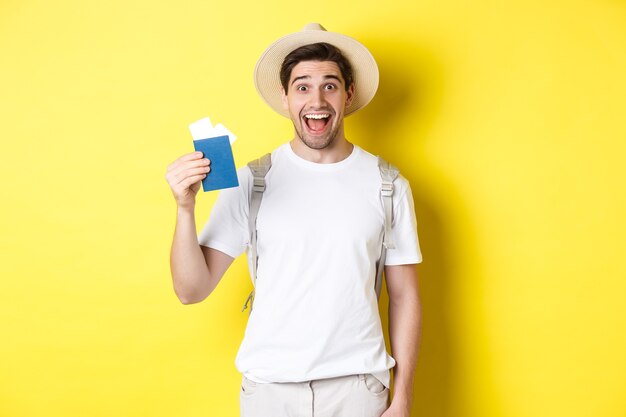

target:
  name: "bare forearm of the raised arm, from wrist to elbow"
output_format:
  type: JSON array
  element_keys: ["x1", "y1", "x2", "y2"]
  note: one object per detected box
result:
[{"x1": 170, "y1": 207, "x2": 215, "y2": 304}]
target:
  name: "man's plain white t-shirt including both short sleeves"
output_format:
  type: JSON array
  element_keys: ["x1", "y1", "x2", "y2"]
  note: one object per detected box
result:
[{"x1": 198, "y1": 143, "x2": 422, "y2": 386}]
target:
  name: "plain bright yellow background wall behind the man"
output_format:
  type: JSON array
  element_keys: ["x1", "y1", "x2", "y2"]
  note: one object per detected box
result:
[{"x1": 0, "y1": 0, "x2": 626, "y2": 417}]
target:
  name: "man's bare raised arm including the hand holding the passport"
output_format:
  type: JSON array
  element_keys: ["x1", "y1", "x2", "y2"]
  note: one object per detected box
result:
[{"x1": 165, "y1": 152, "x2": 233, "y2": 304}]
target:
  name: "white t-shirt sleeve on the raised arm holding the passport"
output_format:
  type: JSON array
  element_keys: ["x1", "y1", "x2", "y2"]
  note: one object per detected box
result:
[{"x1": 198, "y1": 167, "x2": 251, "y2": 258}]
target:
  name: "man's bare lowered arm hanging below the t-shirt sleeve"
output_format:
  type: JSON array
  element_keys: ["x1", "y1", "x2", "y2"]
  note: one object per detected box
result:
[{"x1": 381, "y1": 264, "x2": 422, "y2": 417}]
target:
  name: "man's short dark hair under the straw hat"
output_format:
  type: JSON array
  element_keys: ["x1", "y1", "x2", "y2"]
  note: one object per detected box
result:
[{"x1": 280, "y1": 42, "x2": 352, "y2": 94}]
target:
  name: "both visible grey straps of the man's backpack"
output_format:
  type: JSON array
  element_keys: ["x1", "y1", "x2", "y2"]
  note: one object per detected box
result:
[{"x1": 241, "y1": 153, "x2": 400, "y2": 312}]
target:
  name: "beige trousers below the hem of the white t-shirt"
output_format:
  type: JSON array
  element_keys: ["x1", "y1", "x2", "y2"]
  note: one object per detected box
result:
[{"x1": 239, "y1": 374, "x2": 389, "y2": 417}]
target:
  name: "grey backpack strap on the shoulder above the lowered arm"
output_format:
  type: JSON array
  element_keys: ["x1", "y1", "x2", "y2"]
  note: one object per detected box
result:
[{"x1": 375, "y1": 156, "x2": 400, "y2": 298}]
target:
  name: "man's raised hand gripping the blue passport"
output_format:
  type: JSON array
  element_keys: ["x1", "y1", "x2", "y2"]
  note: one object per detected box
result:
[{"x1": 165, "y1": 152, "x2": 211, "y2": 209}]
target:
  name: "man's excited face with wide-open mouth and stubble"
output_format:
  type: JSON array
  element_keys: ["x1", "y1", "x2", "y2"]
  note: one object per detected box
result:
[{"x1": 283, "y1": 61, "x2": 354, "y2": 149}]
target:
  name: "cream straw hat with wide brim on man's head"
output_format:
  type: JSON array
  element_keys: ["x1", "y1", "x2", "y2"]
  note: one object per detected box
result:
[{"x1": 254, "y1": 23, "x2": 378, "y2": 117}]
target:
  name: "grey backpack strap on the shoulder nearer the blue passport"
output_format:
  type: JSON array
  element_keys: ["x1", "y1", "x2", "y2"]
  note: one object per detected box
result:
[{"x1": 241, "y1": 153, "x2": 272, "y2": 311}]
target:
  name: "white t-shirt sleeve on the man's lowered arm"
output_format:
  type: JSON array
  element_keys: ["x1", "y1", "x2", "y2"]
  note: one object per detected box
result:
[{"x1": 385, "y1": 177, "x2": 422, "y2": 265}]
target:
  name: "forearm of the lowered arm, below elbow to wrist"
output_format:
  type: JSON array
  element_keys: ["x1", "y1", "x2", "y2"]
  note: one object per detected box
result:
[{"x1": 389, "y1": 288, "x2": 421, "y2": 410}]
